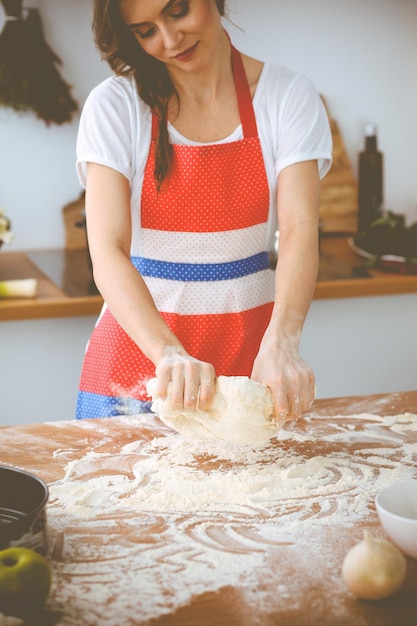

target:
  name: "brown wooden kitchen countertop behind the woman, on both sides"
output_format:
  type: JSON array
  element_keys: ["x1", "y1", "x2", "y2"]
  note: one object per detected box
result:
[{"x1": 0, "y1": 237, "x2": 417, "y2": 321}]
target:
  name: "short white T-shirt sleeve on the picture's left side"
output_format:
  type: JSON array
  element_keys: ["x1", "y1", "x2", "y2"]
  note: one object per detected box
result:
[{"x1": 76, "y1": 77, "x2": 135, "y2": 186}]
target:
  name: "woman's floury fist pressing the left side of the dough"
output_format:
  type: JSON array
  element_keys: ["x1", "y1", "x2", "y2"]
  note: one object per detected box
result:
[{"x1": 155, "y1": 347, "x2": 216, "y2": 411}]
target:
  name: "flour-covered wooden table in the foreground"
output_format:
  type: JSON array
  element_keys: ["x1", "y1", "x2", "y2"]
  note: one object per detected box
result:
[{"x1": 0, "y1": 391, "x2": 417, "y2": 626}]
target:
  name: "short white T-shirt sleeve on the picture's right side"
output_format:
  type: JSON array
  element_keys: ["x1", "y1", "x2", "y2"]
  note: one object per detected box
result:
[{"x1": 275, "y1": 75, "x2": 332, "y2": 178}]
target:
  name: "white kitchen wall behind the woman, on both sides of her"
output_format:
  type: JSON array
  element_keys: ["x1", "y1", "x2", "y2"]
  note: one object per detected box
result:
[{"x1": 0, "y1": 0, "x2": 417, "y2": 250}]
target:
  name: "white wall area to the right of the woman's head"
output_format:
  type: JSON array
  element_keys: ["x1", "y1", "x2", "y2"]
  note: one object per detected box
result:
[{"x1": 226, "y1": 0, "x2": 417, "y2": 221}]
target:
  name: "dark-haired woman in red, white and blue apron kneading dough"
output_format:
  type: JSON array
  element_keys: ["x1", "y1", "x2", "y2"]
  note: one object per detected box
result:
[{"x1": 77, "y1": 0, "x2": 331, "y2": 422}]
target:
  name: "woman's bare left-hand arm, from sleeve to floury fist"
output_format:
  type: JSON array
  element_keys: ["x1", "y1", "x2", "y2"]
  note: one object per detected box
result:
[{"x1": 86, "y1": 163, "x2": 214, "y2": 409}]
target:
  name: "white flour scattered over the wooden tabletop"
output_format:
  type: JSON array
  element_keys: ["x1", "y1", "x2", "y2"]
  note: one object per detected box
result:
[{"x1": 48, "y1": 414, "x2": 417, "y2": 626}]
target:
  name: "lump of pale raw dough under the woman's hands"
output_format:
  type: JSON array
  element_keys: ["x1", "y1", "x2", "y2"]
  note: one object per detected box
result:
[{"x1": 147, "y1": 376, "x2": 279, "y2": 444}]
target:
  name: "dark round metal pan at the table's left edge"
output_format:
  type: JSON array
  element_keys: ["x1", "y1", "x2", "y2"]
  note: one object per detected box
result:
[{"x1": 0, "y1": 465, "x2": 49, "y2": 554}]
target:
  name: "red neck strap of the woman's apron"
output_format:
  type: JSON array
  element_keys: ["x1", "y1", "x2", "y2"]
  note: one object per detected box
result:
[{"x1": 152, "y1": 35, "x2": 258, "y2": 141}]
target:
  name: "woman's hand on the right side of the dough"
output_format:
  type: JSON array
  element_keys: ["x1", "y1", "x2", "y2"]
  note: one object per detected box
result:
[{"x1": 251, "y1": 339, "x2": 315, "y2": 425}]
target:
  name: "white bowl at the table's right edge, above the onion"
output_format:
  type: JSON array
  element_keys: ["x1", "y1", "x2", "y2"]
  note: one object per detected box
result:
[{"x1": 375, "y1": 480, "x2": 417, "y2": 559}]
